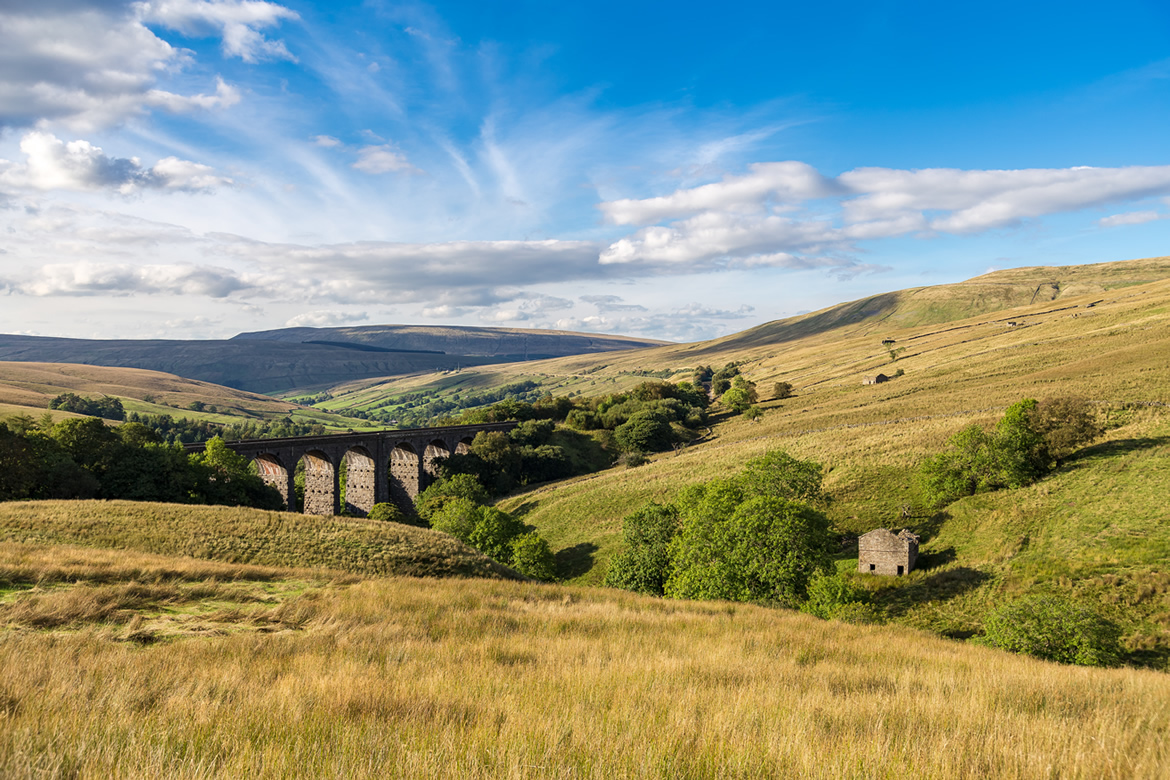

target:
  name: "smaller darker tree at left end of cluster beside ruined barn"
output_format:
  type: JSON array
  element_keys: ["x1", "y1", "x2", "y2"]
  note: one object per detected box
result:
[{"x1": 605, "y1": 503, "x2": 679, "y2": 595}]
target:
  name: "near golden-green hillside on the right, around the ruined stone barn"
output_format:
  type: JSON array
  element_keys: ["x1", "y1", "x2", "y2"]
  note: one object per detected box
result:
[{"x1": 465, "y1": 264, "x2": 1170, "y2": 665}]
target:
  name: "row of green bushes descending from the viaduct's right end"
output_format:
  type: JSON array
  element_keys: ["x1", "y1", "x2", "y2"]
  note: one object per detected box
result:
[{"x1": 414, "y1": 474, "x2": 557, "y2": 581}]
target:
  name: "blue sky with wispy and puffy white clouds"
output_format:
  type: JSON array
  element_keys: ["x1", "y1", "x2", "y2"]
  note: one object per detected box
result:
[{"x1": 0, "y1": 0, "x2": 1170, "y2": 341}]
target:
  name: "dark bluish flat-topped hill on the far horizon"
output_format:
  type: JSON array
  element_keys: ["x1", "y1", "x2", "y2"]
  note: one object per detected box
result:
[{"x1": 0, "y1": 326, "x2": 662, "y2": 393}]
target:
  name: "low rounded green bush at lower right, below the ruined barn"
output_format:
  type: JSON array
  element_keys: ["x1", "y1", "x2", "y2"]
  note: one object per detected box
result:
[{"x1": 982, "y1": 595, "x2": 1121, "y2": 667}]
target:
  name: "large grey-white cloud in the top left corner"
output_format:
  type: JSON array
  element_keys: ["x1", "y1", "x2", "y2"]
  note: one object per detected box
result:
[{"x1": 0, "y1": 0, "x2": 240, "y2": 132}]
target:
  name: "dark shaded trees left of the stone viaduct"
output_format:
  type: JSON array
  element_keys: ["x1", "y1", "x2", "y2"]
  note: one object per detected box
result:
[{"x1": 0, "y1": 416, "x2": 283, "y2": 509}]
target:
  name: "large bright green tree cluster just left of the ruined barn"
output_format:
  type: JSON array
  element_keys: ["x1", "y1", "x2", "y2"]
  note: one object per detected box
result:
[{"x1": 605, "y1": 451, "x2": 834, "y2": 607}]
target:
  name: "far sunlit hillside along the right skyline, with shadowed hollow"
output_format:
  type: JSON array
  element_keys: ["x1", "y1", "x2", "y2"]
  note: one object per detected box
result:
[{"x1": 308, "y1": 257, "x2": 1170, "y2": 418}]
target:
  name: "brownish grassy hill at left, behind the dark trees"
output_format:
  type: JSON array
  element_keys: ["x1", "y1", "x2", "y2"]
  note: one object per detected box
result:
[{"x1": 0, "y1": 361, "x2": 386, "y2": 430}]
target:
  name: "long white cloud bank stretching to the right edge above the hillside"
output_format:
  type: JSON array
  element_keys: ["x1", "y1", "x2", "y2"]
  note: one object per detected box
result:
[{"x1": 600, "y1": 163, "x2": 1170, "y2": 272}]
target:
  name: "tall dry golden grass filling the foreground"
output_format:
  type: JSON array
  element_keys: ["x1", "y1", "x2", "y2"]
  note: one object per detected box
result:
[{"x1": 0, "y1": 579, "x2": 1170, "y2": 778}]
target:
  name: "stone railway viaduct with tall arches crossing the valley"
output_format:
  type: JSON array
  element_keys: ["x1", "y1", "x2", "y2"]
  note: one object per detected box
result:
[{"x1": 186, "y1": 422, "x2": 516, "y2": 516}]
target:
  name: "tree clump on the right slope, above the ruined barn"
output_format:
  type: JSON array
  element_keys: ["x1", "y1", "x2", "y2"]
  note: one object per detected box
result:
[{"x1": 918, "y1": 398, "x2": 1103, "y2": 506}]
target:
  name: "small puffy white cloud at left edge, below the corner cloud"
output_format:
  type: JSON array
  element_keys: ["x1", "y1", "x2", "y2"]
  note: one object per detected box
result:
[{"x1": 0, "y1": 131, "x2": 232, "y2": 194}]
